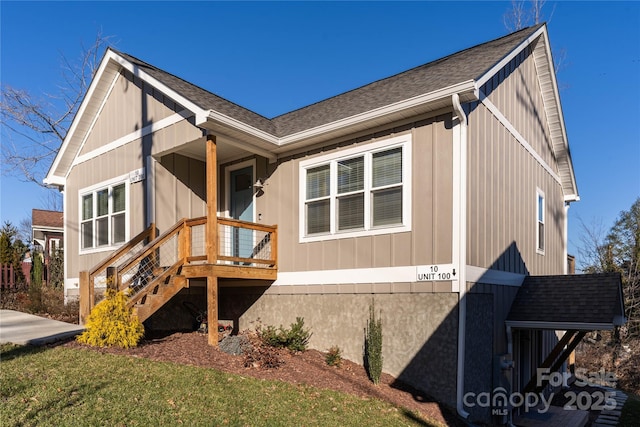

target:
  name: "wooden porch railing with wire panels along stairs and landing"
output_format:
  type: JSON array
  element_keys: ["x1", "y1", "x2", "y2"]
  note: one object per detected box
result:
[{"x1": 80, "y1": 217, "x2": 277, "y2": 324}]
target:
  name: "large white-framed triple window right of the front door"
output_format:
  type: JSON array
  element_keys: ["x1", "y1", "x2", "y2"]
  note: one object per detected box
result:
[{"x1": 300, "y1": 136, "x2": 411, "y2": 241}]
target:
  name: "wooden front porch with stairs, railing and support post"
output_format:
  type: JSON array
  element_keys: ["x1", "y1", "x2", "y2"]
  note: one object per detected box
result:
[{"x1": 80, "y1": 217, "x2": 277, "y2": 345}]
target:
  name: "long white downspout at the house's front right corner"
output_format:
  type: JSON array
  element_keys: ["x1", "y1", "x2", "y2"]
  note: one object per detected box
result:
[{"x1": 451, "y1": 93, "x2": 469, "y2": 419}]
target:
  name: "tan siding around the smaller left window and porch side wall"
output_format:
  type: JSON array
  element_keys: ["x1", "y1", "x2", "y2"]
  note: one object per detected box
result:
[{"x1": 65, "y1": 125, "x2": 201, "y2": 278}]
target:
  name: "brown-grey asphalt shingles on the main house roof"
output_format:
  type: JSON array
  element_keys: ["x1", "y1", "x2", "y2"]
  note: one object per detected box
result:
[{"x1": 112, "y1": 24, "x2": 544, "y2": 137}]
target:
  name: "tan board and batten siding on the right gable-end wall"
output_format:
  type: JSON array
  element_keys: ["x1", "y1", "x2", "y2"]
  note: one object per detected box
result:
[{"x1": 467, "y1": 46, "x2": 566, "y2": 274}]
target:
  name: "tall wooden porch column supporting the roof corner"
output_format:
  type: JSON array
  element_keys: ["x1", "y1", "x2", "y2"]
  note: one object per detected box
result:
[{"x1": 205, "y1": 135, "x2": 218, "y2": 346}]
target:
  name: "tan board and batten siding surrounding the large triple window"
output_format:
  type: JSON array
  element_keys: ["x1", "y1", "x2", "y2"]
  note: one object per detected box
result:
[{"x1": 256, "y1": 114, "x2": 453, "y2": 272}]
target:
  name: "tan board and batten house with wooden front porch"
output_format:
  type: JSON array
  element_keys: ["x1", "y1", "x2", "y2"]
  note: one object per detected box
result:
[{"x1": 45, "y1": 25, "x2": 614, "y2": 422}]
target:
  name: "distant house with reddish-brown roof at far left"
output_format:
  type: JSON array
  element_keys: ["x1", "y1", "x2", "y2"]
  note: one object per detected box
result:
[{"x1": 31, "y1": 209, "x2": 64, "y2": 283}]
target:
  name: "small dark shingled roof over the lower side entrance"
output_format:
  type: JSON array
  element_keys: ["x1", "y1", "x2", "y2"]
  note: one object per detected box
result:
[{"x1": 506, "y1": 273, "x2": 625, "y2": 330}]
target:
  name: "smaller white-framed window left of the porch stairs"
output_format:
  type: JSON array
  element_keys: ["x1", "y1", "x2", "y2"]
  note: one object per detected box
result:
[{"x1": 80, "y1": 182, "x2": 128, "y2": 250}]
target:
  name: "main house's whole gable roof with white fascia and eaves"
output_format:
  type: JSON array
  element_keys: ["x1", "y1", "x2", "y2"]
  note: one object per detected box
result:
[{"x1": 45, "y1": 24, "x2": 578, "y2": 200}]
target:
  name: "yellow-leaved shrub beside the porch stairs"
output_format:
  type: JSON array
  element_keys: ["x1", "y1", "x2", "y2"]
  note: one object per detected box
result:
[{"x1": 77, "y1": 289, "x2": 144, "y2": 348}]
